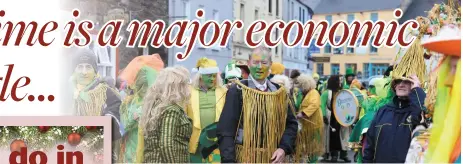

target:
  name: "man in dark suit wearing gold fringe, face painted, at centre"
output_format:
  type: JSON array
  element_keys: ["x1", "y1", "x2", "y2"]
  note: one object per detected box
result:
[{"x1": 217, "y1": 47, "x2": 298, "y2": 163}]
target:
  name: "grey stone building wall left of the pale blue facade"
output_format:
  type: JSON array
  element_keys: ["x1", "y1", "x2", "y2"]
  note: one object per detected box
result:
[{"x1": 61, "y1": 0, "x2": 169, "y2": 69}]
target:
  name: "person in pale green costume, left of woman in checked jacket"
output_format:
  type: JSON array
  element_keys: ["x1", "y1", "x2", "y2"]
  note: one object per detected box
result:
[{"x1": 120, "y1": 66, "x2": 157, "y2": 163}]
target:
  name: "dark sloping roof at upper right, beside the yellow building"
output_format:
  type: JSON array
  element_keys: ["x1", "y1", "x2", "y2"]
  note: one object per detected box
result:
[{"x1": 399, "y1": 0, "x2": 447, "y2": 24}]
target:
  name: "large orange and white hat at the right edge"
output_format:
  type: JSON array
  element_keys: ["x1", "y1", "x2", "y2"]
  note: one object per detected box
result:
[{"x1": 421, "y1": 25, "x2": 461, "y2": 57}]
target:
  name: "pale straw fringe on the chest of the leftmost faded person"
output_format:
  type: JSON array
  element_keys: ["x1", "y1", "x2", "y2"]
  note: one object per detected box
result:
[{"x1": 75, "y1": 84, "x2": 110, "y2": 116}]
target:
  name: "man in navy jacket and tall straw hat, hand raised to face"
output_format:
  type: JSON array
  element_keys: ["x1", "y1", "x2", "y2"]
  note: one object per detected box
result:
[{"x1": 362, "y1": 34, "x2": 426, "y2": 163}]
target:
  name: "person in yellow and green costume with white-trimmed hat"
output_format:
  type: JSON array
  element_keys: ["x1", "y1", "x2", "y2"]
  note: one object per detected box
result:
[{"x1": 187, "y1": 57, "x2": 227, "y2": 163}]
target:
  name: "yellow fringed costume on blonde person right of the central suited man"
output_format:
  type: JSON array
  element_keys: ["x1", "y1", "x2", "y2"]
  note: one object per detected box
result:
[{"x1": 294, "y1": 89, "x2": 325, "y2": 162}]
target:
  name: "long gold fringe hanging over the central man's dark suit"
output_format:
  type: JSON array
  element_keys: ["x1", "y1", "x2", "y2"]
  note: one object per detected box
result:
[{"x1": 236, "y1": 82, "x2": 288, "y2": 163}]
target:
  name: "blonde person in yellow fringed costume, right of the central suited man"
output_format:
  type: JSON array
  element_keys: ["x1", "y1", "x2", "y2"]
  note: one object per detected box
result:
[{"x1": 294, "y1": 74, "x2": 325, "y2": 163}]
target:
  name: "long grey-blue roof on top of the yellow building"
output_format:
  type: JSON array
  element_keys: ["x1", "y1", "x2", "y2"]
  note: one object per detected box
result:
[{"x1": 314, "y1": 0, "x2": 402, "y2": 14}]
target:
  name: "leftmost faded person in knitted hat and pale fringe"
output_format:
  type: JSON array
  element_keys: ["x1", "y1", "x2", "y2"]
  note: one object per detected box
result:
[{"x1": 72, "y1": 49, "x2": 122, "y2": 160}]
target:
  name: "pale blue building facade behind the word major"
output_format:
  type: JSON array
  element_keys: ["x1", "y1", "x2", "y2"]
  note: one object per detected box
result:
[{"x1": 169, "y1": 0, "x2": 233, "y2": 71}]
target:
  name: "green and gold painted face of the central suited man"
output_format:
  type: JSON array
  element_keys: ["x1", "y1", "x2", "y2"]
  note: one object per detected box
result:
[{"x1": 249, "y1": 54, "x2": 271, "y2": 80}]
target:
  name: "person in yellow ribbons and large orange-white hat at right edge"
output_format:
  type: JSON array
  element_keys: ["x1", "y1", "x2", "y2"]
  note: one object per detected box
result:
[{"x1": 422, "y1": 24, "x2": 461, "y2": 163}]
